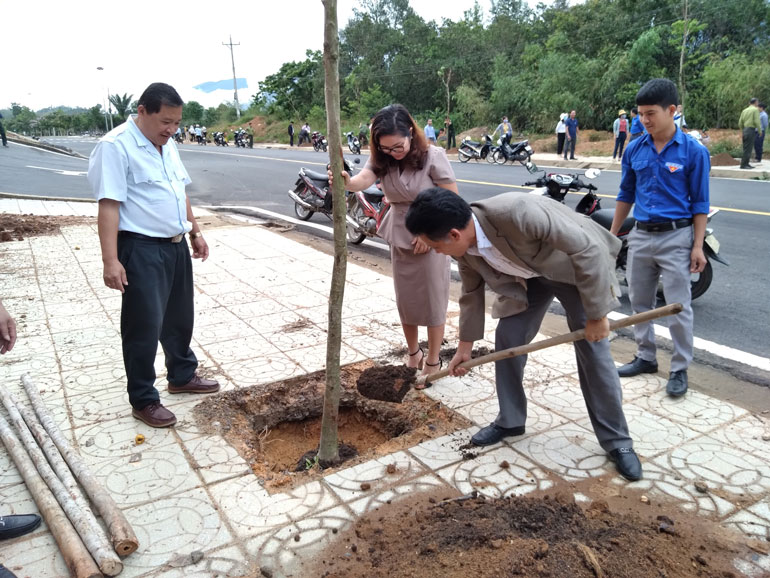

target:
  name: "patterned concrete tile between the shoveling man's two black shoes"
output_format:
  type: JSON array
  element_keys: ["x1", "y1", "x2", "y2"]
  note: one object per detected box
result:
[{"x1": 506, "y1": 423, "x2": 611, "y2": 481}]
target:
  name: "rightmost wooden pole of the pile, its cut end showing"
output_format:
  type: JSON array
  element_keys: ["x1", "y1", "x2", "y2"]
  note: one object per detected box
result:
[{"x1": 21, "y1": 375, "x2": 139, "y2": 556}]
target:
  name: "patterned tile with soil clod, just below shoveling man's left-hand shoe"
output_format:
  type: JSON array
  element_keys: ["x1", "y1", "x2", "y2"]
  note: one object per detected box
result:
[{"x1": 436, "y1": 446, "x2": 553, "y2": 498}]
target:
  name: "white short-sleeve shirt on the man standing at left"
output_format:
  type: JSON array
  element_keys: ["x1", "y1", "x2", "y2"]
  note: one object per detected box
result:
[{"x1": 88, "y1": 116, "x2": 192, "y2": 237}]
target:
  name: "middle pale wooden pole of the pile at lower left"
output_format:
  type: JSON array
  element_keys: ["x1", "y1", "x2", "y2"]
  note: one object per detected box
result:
[{"x1": 0, "y1": 385, "x2": 123, "y2": 576}]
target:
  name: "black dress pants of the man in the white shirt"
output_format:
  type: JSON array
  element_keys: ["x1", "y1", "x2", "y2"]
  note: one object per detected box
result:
[{"x1": 118, "y1": 234, "x2": 198, "y2": 409}]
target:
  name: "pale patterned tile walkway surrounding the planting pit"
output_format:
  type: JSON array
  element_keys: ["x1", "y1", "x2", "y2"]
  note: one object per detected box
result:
[{"x1": 0, "y1": 199, "x2": 770, "y2": 578}]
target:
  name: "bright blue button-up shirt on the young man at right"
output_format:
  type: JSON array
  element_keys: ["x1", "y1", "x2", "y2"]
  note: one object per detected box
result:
[{"x1": 617, "y1": 127, "x2": 711, "y2": 222}]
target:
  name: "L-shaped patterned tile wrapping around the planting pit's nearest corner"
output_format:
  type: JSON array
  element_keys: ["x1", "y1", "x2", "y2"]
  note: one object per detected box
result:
[{"x1": 209, "y1": 475, "x2": 337, "y2": 539}]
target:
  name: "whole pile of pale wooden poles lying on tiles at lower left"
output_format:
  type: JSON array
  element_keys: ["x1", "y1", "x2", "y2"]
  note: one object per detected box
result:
[{"x1": 0, "y1": 375, "x2": 139, "y2": 578}]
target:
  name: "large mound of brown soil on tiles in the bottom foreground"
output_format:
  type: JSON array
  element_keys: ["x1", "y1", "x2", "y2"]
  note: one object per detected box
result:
[{"x1": 316, "y1": 494, "x2": 748, "y2": 578}]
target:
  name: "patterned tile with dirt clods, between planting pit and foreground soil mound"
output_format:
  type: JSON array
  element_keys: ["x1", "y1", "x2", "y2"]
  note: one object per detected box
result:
[{"x1": 323, "y1": 452, "x2": 426, "y2": 502}]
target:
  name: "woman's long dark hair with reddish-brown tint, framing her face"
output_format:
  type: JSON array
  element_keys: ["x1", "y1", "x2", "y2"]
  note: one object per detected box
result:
[{"x1": 369, "y1": 104, "x2": 429, "y2": 177}]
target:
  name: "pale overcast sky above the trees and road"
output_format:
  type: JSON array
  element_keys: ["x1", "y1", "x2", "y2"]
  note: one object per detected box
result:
[{"x1": 0, "y1": 0, "x2": 498, "y2": 110}]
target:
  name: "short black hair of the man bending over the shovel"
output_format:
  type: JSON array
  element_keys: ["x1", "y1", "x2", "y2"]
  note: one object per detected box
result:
[{"x1": 406, "y1": 187, "x2": 472, "y2": 241}]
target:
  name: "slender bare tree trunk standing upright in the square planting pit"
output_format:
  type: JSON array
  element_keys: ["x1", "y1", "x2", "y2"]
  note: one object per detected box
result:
[{"x1": 318, "y1": 0, "x2": 348, "y2": 464}]
